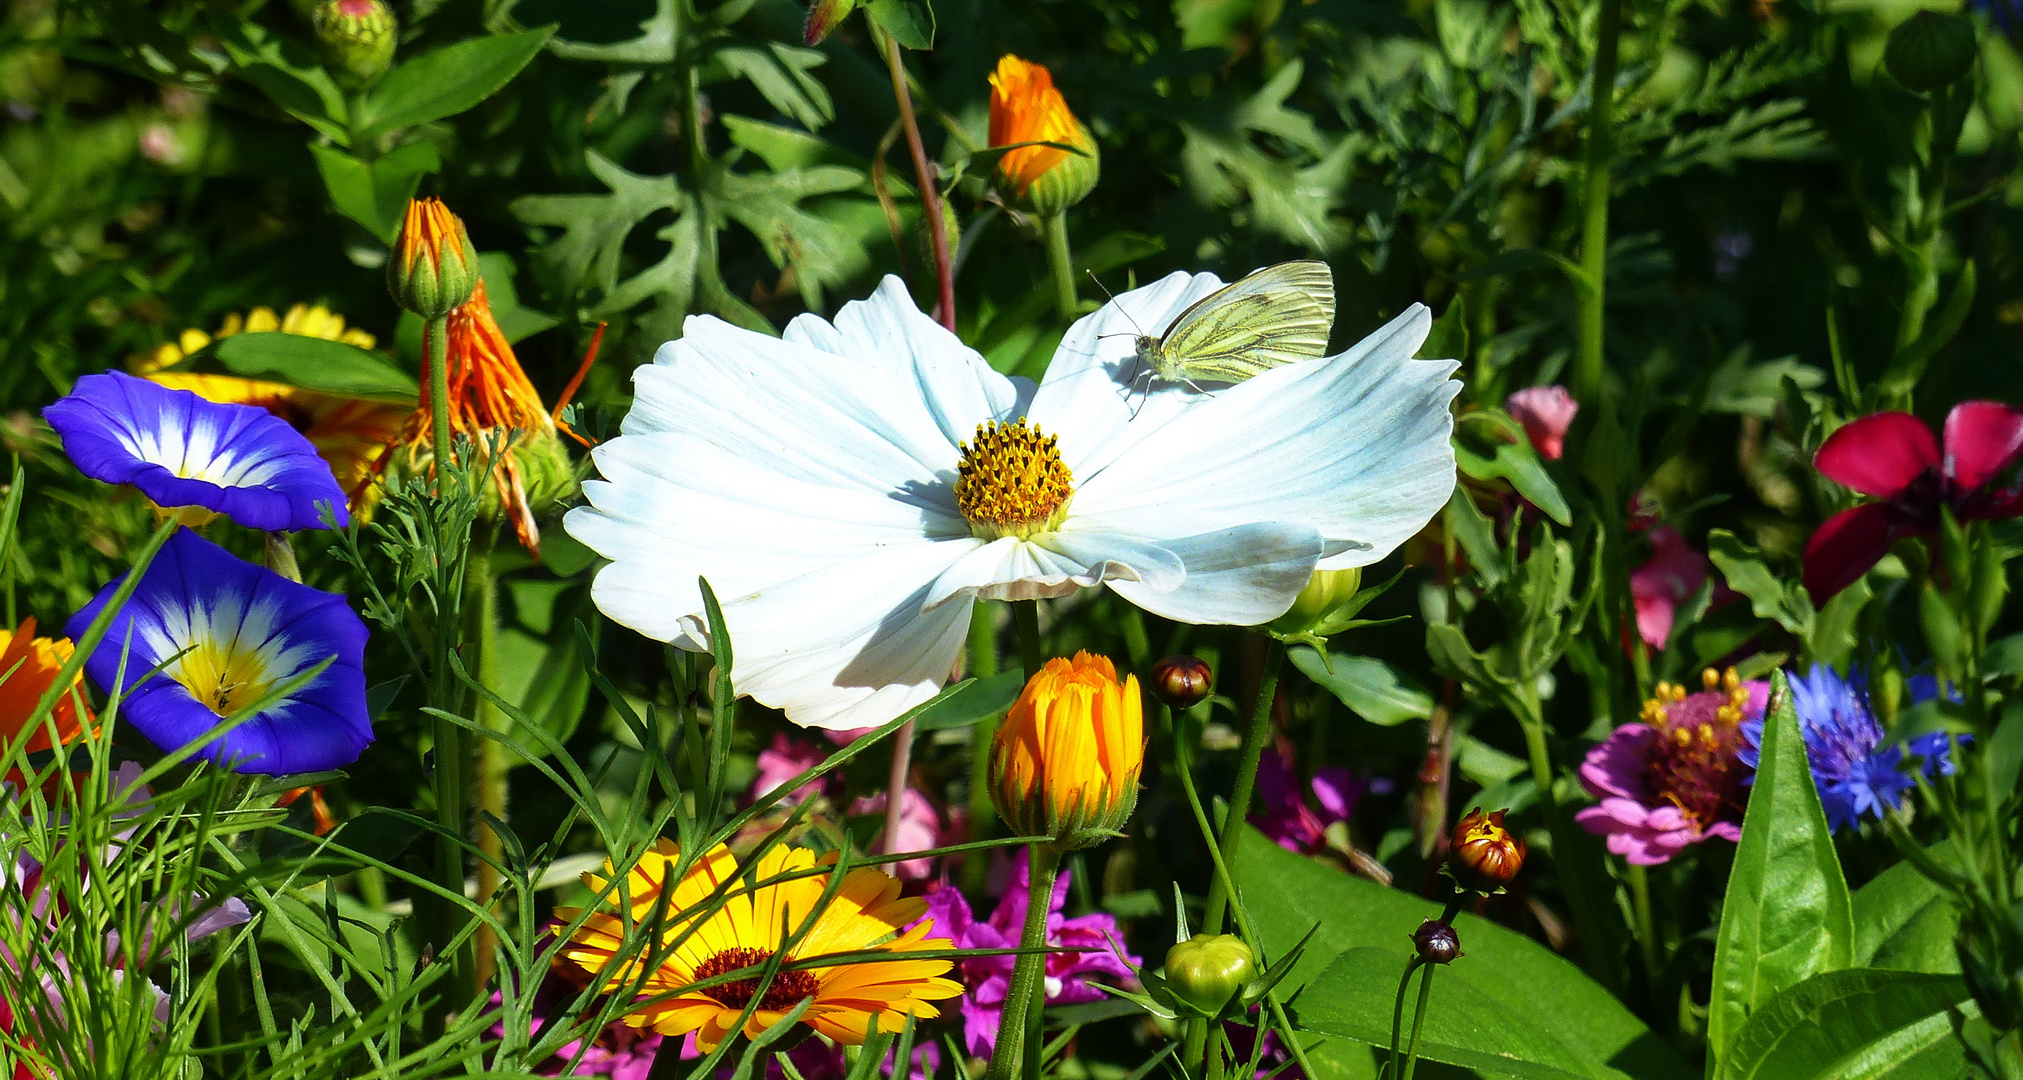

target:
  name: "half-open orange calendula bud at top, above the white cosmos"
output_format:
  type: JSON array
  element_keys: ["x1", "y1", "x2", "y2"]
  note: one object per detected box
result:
[{"x1": 991, "y1": 55, "x2": 1101, "y2": 216}]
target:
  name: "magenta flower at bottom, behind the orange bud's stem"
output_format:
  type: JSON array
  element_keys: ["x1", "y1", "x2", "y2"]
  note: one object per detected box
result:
[{"x1": 927, "y1": 851, "x2": 1145, "y2": 1058}]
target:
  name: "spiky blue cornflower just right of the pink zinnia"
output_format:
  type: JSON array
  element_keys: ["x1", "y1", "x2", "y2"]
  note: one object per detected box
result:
[{"x1": 1736, "y1": 663, "x2": 1952, "y2": 831}]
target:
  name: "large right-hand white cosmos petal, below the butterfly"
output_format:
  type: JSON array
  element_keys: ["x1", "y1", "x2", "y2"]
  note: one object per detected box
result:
[{"x1": 1074, "y1": 303, "x2": 1461, "y2": 568}]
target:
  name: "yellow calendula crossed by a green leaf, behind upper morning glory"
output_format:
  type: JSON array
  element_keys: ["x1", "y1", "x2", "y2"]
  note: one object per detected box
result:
[{"x1": 131, "y1": 303, "x2": 409, "y2": 514}]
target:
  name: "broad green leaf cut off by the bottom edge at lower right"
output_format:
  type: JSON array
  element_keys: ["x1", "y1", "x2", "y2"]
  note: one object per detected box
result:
[{"x1": 1716, "y1": 969, "x2": 1968, "y2": 1080}]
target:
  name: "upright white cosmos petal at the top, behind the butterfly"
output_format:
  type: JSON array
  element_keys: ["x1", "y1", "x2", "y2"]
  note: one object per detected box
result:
[{"x1": 1030, "y1": 271, "x2": 1222, "y2": 479}]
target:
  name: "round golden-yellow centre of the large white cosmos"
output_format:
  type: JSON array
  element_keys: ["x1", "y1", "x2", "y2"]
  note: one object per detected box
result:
[{"x1": 955, "y1": 417, "x2": 1074, "y2": 540}]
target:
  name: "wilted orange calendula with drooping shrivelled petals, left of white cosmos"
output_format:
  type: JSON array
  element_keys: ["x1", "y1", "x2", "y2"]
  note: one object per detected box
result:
[{"x1": 401, "y1": 279, "x2": 568, "y2": 556}]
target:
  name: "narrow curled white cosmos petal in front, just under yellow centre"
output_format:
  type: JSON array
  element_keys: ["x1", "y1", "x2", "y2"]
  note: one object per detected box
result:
[{"x1": 927, "y1": 532, "x2": 1188, "y2": 607}]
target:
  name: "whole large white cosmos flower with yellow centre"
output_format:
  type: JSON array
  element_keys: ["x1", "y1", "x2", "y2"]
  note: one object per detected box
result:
[{"x1": 566, "y1": 273, "x2": 1461, "y2": 728}]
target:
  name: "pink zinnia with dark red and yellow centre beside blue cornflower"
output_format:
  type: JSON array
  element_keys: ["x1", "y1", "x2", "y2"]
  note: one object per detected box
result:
[{"x1": 1574, "y1": 667, "x2": 1770, "y2": 866}]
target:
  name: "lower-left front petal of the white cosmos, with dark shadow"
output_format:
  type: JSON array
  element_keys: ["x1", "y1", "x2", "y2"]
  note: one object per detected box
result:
[{"x1": 679, "y1": 540, "x2": 977, "y2": 728}]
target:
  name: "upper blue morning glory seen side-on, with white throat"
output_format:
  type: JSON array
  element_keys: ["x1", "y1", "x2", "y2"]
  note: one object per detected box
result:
[{"x1": 42, "y1": 372, "x2": 350, "y2": 530}]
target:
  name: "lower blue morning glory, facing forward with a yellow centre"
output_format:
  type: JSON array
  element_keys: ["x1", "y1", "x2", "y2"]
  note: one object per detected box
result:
[{"x1": 65, "y1": 530, "x2": 372, "y2": 775}]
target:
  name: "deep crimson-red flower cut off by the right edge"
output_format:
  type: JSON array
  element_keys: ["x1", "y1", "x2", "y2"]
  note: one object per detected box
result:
[{"x1": 1805, "y1": 400, "x2": 2023, "y2": 605}]
